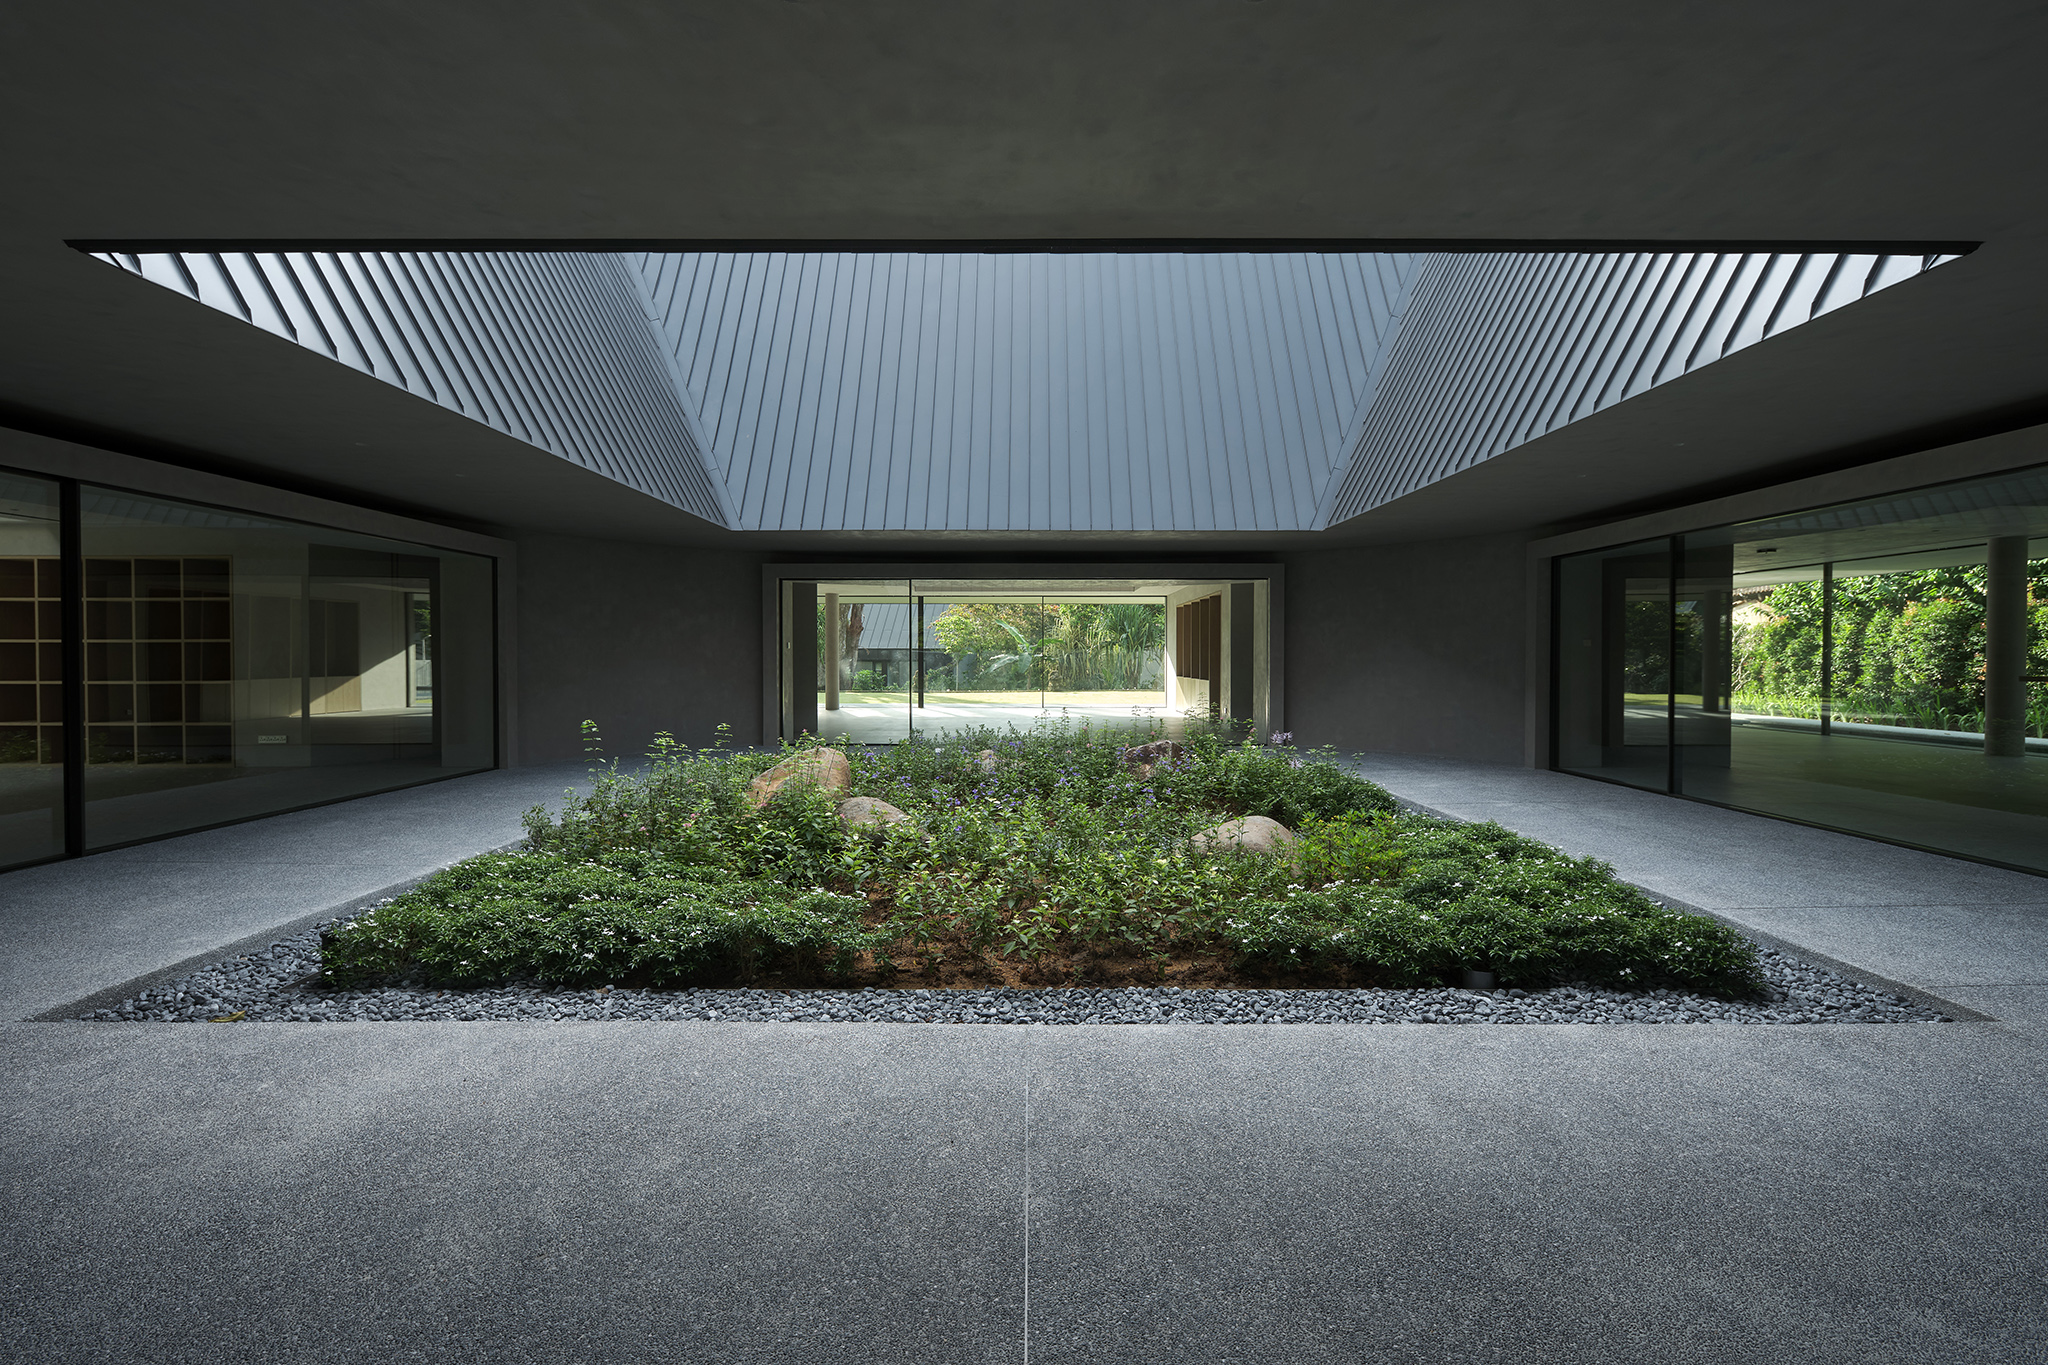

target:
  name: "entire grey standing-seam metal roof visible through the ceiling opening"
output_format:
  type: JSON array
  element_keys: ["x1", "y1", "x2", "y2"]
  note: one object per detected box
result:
[{"x1": 98, "y1": 252, "x2": 1952, "y2": 532}]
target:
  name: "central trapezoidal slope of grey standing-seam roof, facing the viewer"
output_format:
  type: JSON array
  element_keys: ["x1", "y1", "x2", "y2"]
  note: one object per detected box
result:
[{"x1": 633, "y1": 252, "x2": 1417, "y2": 530}]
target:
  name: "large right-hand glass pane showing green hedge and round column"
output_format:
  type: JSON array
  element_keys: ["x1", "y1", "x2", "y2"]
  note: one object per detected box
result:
[{"x1": 1679, "y1": 471, "x2": 2048, "y2": 870}]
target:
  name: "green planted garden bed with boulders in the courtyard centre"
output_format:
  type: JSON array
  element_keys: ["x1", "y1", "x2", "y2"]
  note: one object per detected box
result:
[{"x1": 319, "y1": 729, "x2": 1761, "y2": 999}]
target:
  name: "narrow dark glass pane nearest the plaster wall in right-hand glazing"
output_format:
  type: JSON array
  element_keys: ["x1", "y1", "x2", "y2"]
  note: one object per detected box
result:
[{"x1": 1556, "y1": 540, "x2": 1671, "y2": 792}]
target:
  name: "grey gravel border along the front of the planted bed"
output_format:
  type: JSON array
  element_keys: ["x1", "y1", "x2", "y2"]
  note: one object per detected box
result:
[{"x1": 80, "y1": 916, "x2": 1950, "y2": 1023}]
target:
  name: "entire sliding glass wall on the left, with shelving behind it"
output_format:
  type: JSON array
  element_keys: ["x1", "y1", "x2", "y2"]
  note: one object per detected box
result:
[{"x1": 0, "y1": 471, "x2": 498, "y2": 868}]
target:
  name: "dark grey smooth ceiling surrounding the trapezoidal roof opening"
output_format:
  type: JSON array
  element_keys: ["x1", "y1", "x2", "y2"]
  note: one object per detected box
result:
[{"x1": 0, "y1": 0, "x2": 2048, "y2": 551}]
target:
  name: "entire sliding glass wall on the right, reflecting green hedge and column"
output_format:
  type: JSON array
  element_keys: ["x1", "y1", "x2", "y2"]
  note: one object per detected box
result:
[{"x1": 1552, "y1": 469, "x2": 2048, "y2": 872}]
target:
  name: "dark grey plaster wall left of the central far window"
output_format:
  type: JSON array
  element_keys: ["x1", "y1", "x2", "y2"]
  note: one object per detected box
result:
[{"x1": 518, "y1": 536, "x2": 762, "y2": 765}]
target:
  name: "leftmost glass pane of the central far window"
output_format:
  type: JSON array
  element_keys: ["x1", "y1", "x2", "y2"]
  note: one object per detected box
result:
[{"x1": 815, "y1": 579, "x2": 915, "y2": 745}]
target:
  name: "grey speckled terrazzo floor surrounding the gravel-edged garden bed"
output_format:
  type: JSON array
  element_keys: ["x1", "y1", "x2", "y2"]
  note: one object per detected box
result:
[{"x1": 0, "y1": 757, "x2": 2048, "y2": 1365}]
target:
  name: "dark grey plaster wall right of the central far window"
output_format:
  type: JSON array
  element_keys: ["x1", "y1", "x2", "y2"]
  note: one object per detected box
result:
[{"x1": 1284, "y1": 536, "x2": 1530, "y2": 763}]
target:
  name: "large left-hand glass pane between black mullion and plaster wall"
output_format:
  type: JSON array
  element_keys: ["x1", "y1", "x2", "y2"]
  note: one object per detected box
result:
[{"x1": 82, "y1": 487, "x2": 496, "y2": 847}]
